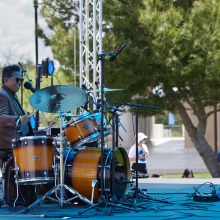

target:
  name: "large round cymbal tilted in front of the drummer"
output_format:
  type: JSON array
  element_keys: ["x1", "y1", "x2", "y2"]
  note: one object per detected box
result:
[{"x1": 30, "y1": 85, "x2": 87, "y2": 113}]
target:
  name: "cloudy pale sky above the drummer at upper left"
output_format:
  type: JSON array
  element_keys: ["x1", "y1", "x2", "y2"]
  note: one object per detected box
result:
[{"x1": 0, "y1": 0, "x2": 53, "y2": 65}]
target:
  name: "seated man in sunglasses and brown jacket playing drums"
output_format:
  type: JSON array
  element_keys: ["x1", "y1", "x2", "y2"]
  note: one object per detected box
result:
[{"x1": 0, "y1": 65, "x2": 33, "y2": 155}]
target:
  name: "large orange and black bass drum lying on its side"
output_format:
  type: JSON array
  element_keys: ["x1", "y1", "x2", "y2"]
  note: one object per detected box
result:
[{"x1": 65, "y1": 147, "x2": 130, "y2": 202}]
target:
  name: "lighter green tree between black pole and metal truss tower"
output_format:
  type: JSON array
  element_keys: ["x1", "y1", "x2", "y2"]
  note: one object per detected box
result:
[{"x1": 37, "y1": 0, "x2": 79, "y2": 84}]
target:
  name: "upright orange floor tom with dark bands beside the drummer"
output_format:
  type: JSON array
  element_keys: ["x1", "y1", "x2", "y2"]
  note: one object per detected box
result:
[{"x1": 12, "y1": 136, "x2": 54, "y2": 185}]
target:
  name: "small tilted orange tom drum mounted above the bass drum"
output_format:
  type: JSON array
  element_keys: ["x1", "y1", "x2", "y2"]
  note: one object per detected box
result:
[{"x1": 65, "y1": 112, "x2": 110, "y2": 147}]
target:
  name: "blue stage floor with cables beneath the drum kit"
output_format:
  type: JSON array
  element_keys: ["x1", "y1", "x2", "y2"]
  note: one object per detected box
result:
[{"x1": 0, "y1": 178, "x2": 220, "y2": 220}]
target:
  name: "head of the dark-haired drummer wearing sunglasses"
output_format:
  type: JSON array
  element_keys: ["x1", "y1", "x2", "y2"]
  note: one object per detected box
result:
[{"x1": 2, "y1": 65, "x2": 23, "y2": 93}]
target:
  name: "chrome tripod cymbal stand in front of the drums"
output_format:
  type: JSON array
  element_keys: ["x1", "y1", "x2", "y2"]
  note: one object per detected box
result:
[{"x1": 25, "y1": 113, "x2": 93, "y2": 212}]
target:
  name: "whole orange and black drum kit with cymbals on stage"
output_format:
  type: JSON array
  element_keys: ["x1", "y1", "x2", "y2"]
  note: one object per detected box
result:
[{"x1": 3, "y1": 85, "x2": 130, "y2": 209}]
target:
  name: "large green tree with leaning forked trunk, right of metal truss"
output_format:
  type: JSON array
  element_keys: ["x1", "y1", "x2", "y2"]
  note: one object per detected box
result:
[{"x1": 38, "y1": 0, "x2": 220, "y2": 177}]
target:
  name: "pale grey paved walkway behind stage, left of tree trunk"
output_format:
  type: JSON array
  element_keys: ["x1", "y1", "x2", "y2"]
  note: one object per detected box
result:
[{"x1": 148, "y1": 137, "x2": 208, "y2": 175}]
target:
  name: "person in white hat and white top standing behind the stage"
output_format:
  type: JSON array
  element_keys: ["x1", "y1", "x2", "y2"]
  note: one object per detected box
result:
[{"x1": 128, "y1": 133, "x2": 150, "y2": 174}]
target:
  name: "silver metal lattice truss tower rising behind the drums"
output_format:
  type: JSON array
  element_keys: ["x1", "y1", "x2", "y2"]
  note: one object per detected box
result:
[{"x1": 79, "y1": 0, "x2": 102, "y2": 97}]
